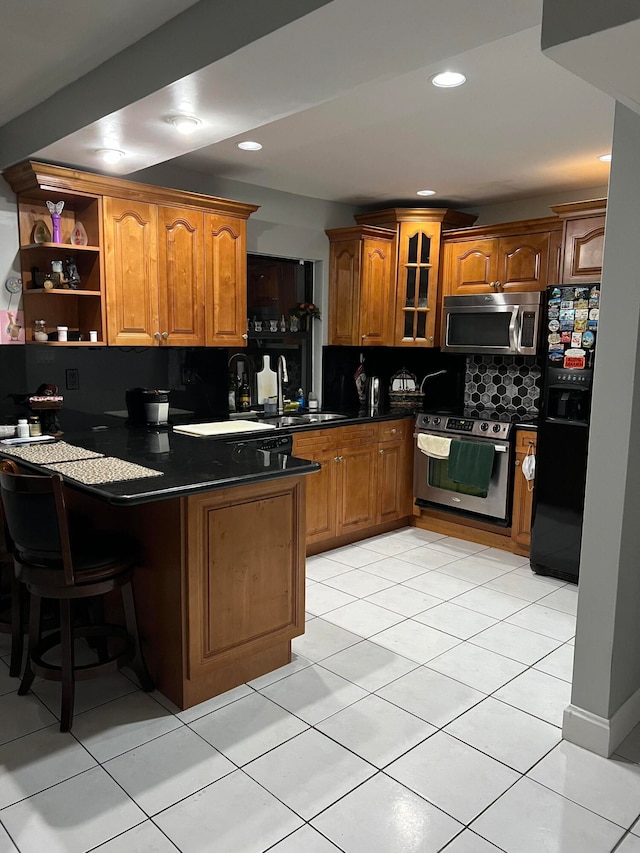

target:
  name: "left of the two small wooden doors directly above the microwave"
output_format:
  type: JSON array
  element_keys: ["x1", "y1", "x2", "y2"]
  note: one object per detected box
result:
[{"x1": 443, "y1": 238, "x2": 498, "y2": 296}]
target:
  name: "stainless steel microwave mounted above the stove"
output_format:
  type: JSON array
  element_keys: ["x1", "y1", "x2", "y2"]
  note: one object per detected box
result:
[{"x1": 442, "y1": 292, "x2": 543, "y2": 355}]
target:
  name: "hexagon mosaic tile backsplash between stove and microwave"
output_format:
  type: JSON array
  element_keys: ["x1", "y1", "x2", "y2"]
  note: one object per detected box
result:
[{"x1": 464, "y1": 355, "x2": 542, "y2": 418}]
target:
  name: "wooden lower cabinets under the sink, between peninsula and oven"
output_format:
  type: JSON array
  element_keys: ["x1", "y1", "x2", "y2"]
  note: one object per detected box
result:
[{"x1": 293, "y1": 419, "x2": 413, "y2": 553}]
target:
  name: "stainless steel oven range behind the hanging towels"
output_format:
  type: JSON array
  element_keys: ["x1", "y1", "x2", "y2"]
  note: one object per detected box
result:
[{"x1": 413, "y1": 414, "x2": 513, "y2": 524}]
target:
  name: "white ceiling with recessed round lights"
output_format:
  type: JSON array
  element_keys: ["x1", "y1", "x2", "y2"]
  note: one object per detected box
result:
[{"x1": 0, "y1": 0, "x2": 614, "y2": 206}]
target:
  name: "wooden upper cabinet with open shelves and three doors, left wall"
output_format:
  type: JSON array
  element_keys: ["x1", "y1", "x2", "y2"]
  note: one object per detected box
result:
[{"x1": 4, "y1": 161, "x2": 258, "y2": 346}]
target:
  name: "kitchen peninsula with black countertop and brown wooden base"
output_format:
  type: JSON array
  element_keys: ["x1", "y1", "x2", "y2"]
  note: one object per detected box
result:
[{"x1": 3, "y1": 425, "x2": 319, "y2": 709}]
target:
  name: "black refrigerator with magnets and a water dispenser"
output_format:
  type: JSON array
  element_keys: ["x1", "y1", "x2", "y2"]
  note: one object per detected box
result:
[{"x1": 530, "y1": 283, "x2": 600, "y2": 583}]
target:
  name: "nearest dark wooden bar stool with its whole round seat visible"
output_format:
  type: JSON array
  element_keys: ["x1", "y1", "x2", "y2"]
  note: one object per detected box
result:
[{"x1": 0, "y1": 459, "x2": 154, "y2": 731}]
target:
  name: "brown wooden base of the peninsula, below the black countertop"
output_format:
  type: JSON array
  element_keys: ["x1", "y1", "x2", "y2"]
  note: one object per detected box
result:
[{"x1": 98, "y1": 477, "x2": 305, "y2": 709}]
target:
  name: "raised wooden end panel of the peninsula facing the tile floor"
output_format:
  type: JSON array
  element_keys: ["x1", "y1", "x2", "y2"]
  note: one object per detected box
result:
[{"x1": 187, "y1": 478, "x2": 304, "y2": 683}]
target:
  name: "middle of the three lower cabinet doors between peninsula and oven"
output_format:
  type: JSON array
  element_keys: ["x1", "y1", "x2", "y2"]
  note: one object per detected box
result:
[{"x1": 337, "y1": 444, "x2": 378, "y2": 536}]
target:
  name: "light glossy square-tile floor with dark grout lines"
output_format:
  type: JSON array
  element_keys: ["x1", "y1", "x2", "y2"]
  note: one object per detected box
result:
[{"x1": 0, "y1": 528, "x2": 640, "y2": 853}]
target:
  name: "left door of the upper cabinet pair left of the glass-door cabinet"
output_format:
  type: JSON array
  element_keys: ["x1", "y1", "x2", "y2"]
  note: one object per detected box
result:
[{"x1": 329, "y1": 240, "x2": 361, "y2": 346}]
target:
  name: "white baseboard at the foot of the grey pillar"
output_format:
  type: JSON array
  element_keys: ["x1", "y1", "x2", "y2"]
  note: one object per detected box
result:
[{"x1": 562, "y1": 689, "x2": 640, "y2": 758}]
